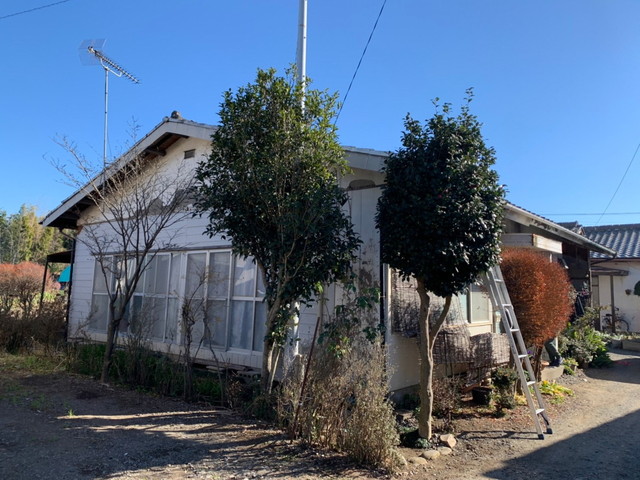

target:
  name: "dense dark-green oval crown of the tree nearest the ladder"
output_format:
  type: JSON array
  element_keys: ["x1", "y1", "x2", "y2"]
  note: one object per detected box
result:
[{"x1": 376, "y1": 92, "x2": 504, "y2": 297}]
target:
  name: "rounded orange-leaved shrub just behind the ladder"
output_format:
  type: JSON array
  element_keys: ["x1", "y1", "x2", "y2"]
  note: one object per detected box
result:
[{"x1": 500, "y1": 248, "x2": 573, "y2": 348}]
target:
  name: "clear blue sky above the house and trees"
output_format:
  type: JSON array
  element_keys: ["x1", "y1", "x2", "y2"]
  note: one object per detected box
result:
[{"x1": 0, "y1": 0, "x2": 640, "y2": 225}]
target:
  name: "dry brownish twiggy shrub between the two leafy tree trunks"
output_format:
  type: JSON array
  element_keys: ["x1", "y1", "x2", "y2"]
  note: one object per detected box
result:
[{"x1": 278, "y1": 289, "x2": 399, "y2": 469}]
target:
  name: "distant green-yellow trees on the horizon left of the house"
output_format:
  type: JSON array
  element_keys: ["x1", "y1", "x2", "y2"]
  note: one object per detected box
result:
[{"x1": 0, "y1": 205, "x2": 71, "y2": 264}]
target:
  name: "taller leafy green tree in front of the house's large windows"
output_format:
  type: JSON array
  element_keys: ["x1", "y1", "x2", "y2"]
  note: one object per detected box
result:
[{"x1": 196, "y1": 66, "x2": 359, "y2": 389}]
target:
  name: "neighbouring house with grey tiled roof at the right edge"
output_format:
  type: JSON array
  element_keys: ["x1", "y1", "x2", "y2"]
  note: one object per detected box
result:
[{"x1": 580, "y1": 223, "x2": 640, "y2": 332}]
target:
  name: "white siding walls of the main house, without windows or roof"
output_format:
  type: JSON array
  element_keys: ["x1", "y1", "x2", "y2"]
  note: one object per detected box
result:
[{"x1": 65, "y1": 134, "x2": 510, "y2": 390}]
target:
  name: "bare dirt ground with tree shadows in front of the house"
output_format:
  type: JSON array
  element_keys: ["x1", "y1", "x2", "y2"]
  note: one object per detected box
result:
[{"x1": 0, "y1": 351, "x2": 640, "y2": 480}]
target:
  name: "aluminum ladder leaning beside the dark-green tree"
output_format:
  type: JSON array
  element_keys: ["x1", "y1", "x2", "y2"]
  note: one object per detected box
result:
[{"x1": 482, "y1": 265, "x2": 553, "y2": 440}]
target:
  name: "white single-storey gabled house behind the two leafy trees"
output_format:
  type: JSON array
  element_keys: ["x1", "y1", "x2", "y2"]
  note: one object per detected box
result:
[{"x1": 43, "y1": 118, "x2": 612, "y2": 390}]
